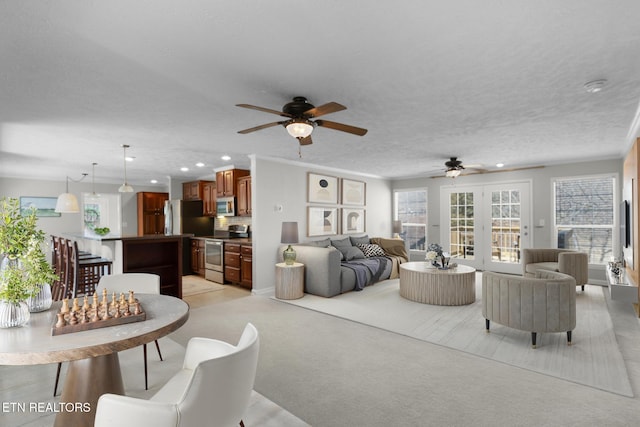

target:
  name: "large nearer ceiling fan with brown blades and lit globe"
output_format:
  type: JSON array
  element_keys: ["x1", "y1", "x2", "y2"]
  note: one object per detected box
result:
[{"x1": 236, "y1": 96, "x2": 367, "y2": 145}]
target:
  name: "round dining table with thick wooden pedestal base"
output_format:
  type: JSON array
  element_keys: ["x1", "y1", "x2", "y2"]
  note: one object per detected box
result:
[{"x1": 0, "y1": 294, "x2": 189, "y2": 427}]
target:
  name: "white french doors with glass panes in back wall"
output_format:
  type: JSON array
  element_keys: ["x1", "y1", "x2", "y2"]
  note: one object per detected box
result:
[{"x1": 440, "y1": 182, "x2": 531, "y2": 274}]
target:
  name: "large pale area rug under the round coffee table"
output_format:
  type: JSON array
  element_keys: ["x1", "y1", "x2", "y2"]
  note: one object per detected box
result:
[{"x1": 282, "y1": 273, "x2": 633, "y2": 396}]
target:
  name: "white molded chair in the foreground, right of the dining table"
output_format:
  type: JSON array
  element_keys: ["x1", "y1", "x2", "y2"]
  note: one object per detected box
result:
[{"x1": 94, "y1": 323, "x2": 259, "y2": 427}]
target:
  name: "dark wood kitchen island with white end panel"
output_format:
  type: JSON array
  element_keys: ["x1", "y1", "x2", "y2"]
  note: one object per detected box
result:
[{"x1": 66, "y1": 235, "x2": 190, "y2": 298}]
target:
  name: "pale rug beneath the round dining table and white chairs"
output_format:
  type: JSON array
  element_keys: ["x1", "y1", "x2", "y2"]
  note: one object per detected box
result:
[{"x1": 0, "y1": 338, "x2": 308, "y2": 427}]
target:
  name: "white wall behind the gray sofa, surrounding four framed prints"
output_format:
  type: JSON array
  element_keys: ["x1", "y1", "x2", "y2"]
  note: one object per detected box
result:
[{"x1": 251, "y1": 156, "x2": 392, "y2": 293}]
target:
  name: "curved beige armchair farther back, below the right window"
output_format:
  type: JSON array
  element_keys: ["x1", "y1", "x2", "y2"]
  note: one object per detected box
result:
[{"x1": 522, "y1": 248, "x2": 589, "y2": 291}]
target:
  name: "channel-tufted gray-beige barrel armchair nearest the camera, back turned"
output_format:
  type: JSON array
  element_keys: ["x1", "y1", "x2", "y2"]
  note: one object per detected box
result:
[{"x1": 482, "y1": 270, "x2": 576, "y2": 348}]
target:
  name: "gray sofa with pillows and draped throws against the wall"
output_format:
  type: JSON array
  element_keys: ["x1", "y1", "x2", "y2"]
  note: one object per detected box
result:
[{"x1": 278, "y1": 236, "x2": 408, "y2": 297}]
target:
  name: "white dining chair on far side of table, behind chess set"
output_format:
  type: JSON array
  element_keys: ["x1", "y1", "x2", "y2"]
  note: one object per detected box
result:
[{"x1": 53, "y1": 273, "x2": 163, "y2": 396}]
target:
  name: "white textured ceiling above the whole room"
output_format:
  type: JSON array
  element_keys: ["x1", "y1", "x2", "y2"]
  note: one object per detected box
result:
[{"x1": 0, "y1": 0, "x2": 640, "y2": 185}]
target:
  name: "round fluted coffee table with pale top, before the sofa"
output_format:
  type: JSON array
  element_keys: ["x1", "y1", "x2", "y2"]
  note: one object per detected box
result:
[{"x1": 400, "y1": 262, "x2": 476, "y2": 305}]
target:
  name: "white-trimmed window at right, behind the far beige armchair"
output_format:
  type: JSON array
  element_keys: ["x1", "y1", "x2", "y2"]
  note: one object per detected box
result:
[{"x1": 553, "y1": 175, "x2": 618, "y2": 264}]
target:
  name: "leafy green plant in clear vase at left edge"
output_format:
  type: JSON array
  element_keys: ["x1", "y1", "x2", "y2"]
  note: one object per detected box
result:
[{"x1": 0, "y1": 198, "x2": 56, "y2": 327}]
